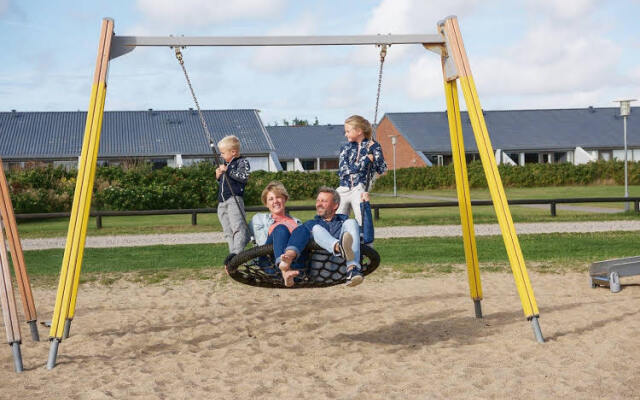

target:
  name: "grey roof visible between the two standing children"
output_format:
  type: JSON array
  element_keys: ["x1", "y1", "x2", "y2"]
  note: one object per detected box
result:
[{"x1": 267, "y1": 125, "x2": 347, "y2": 161}]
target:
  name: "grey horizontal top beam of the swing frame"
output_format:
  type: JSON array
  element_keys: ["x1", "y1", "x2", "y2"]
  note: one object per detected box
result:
[{"x1": 111, "y1": 34, "x2": 444, "y2": 58}]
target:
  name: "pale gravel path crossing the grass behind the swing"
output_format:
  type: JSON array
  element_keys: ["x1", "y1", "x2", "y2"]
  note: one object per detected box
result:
[{"x1": 22, "y1": 221, "x2": 640, "y2": 250}]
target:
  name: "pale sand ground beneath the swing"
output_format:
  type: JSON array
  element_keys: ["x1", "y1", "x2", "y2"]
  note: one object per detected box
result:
[{"x1": 0, "y1": 273, "x2": 640, "y2": 399}]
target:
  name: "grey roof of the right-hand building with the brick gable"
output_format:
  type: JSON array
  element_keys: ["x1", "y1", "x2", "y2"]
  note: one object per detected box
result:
[{"x1": 385, "y1": 107, "x2": 640, "y2": 154}]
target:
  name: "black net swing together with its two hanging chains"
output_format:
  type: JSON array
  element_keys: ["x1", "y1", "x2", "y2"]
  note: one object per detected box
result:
[{"x1": 175, "y1": 45, "x2": 387, "y2": 289}]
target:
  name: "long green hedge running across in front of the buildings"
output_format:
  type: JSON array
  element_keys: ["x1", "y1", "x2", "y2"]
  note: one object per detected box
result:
[{"x1": 7, "y1": 161, "x2": 640, "y2": 213}]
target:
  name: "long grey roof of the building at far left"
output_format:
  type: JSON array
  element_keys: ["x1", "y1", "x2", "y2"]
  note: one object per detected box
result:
[{"x1": 0, "y1": 110, "x2": 273, "y2": 159}]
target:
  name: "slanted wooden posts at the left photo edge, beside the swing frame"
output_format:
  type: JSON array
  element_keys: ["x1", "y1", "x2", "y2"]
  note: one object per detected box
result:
[{"x1": 0, "y1": 160, "x2": 40, "y2": 372}]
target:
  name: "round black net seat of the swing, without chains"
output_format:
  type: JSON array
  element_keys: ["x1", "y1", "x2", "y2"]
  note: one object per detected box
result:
[{"x1": 227, "y1": 241, "x2": 380, "y2": 289}]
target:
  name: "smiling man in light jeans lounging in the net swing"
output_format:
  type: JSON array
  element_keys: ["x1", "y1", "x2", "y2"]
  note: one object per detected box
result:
[{"x1": 278, "y1": 186, "x2": 364, "y2": 287}]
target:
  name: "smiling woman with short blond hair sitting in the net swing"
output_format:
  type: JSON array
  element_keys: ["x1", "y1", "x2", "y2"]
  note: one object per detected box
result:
[{"x1": 251, "y1": 181, "x2": 301, "y2": 283}]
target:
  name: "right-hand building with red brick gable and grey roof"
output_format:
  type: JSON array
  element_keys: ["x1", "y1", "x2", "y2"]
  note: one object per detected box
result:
[{"x1": 377, "y1": 107, "x2": 640, "y2": 168}]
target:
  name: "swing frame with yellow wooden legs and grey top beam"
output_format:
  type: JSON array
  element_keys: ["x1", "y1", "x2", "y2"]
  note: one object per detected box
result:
[{"x1": 47, "y1": 16, "x2": 544, "y2": 369}]
